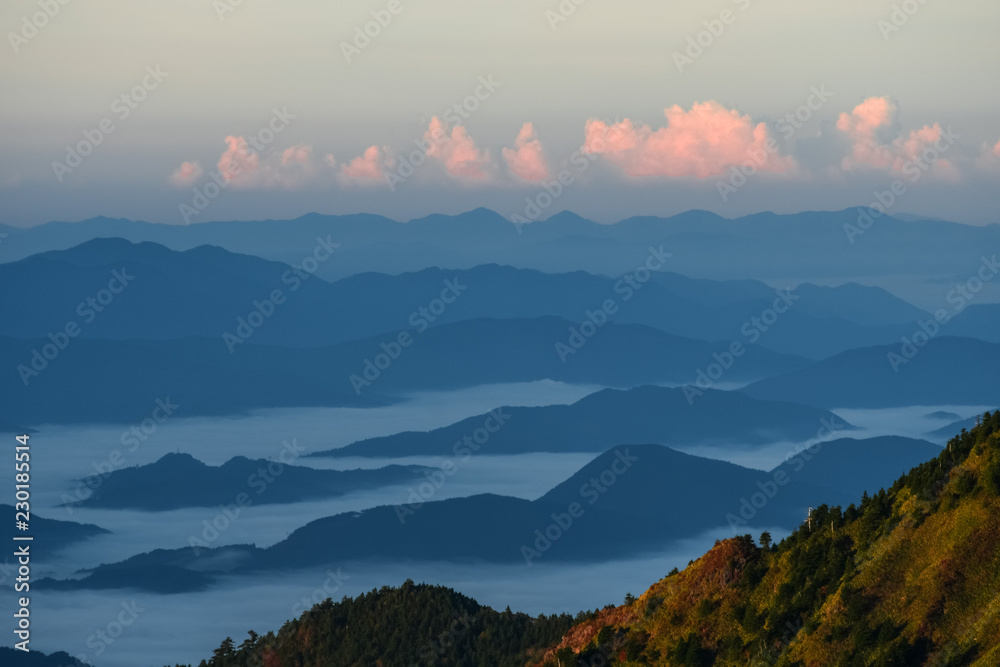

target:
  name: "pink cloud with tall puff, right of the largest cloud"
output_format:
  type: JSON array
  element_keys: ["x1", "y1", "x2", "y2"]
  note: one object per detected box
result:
[{"x1": 837, "y1": 97, "x2": 956, "y2": 176}]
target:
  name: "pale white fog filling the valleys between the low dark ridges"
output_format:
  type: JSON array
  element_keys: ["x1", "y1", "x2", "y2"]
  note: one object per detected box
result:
[{"x1": 0, "y1": 381, "x2": 987, "y2": 667}]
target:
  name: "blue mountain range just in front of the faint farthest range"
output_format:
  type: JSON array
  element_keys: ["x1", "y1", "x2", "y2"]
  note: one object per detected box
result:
[{"x1": 0, "y1": 239, "x2": 929, "y2": 358}]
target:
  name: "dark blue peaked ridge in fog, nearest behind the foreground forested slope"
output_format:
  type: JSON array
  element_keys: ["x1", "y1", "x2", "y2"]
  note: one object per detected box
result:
[{"x1": 39, "y1": 437, "x2": 941, "y2": 592}]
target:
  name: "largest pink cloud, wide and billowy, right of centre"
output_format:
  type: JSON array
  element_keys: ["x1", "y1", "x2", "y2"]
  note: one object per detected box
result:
[{"x1": 583, "y1": 101, "x2": 796, "y2": 178}]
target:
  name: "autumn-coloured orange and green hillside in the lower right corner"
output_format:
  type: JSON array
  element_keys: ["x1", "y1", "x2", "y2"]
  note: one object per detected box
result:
[{"x1": 542, "y1": 412, "x2": 1000, "y2": 667}]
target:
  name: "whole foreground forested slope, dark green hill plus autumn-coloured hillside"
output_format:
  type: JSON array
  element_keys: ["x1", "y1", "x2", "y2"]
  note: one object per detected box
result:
[{"x1": 180, "y1": 411, "x2": 1000, "y2": 667}]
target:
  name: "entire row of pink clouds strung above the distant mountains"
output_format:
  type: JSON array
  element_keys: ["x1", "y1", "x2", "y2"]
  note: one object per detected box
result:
[{"x1": 170, "y1": 97, "x2": 988, "y2": 189}]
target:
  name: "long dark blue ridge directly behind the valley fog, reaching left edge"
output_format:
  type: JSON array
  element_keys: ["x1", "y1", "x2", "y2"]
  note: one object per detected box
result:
[{"x1": 0, "y1": 317, "x2": 806, "y2": 424}]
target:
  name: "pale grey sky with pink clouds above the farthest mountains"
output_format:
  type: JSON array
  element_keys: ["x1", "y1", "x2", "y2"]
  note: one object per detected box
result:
[{"x1": 0, "y1": 0, "x2": 1000, "y2": 226}]
